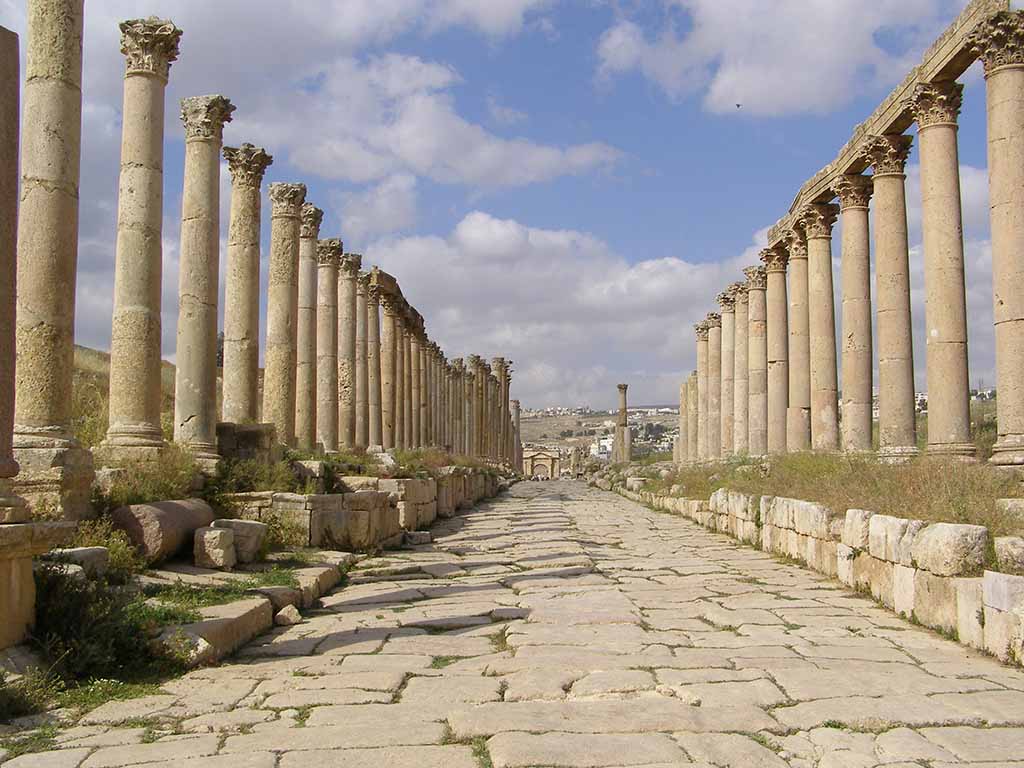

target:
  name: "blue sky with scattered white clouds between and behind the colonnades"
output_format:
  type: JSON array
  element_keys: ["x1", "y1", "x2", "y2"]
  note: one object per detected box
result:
[{"x1": 0, "y1": 0, "x2": 992, "y2": 407}]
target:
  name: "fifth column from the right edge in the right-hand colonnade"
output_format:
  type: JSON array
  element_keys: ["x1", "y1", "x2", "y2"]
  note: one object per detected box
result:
[{"x1": 801, "y1": 203, "x2": 839, "y2": 451}]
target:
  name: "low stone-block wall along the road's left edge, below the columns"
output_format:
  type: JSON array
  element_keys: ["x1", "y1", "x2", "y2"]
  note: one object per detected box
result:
[{"x1": 229, "y1": 467, "x2": 500, "y2": 552}]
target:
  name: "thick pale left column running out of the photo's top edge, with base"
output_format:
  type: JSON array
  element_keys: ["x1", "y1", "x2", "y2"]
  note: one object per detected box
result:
[{"x1": 12, "y1": 0, "x2": 93, "y2": 522}]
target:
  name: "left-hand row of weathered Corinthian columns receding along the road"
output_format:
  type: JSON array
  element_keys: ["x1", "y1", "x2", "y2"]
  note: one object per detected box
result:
[{"x1": 0, "y1": 0, "x2": 519, "y2": 517}]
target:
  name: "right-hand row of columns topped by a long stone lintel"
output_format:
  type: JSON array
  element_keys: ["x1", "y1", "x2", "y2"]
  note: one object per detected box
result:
[{"x1": 676, "y1": 6, "x2": 1024, "y2": 467}]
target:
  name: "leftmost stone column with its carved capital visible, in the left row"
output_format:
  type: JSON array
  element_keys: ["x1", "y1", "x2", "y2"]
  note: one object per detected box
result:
[{"x1": 103, "y1": 18, "x2": 181, "y2": 461}]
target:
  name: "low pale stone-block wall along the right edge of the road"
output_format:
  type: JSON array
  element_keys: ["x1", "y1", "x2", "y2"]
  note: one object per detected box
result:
[{"x1": 606, "y1": 479, "x2": 1024, "y2": 666}]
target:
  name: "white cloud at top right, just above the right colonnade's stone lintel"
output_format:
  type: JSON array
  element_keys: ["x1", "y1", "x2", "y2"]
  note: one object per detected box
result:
[{"x1": 597, "y1": 0, "x2": 966, "y2": 116}]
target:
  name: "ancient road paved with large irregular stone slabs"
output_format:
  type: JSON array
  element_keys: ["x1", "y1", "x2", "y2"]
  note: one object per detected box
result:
[{"x1": 14, "y1": 482, "x2": 1024, "y2": 768}]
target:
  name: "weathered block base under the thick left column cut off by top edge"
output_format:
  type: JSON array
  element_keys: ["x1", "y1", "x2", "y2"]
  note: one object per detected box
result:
[{"x1": 11, "y1": 439, "x2": 95, "y2": 520}]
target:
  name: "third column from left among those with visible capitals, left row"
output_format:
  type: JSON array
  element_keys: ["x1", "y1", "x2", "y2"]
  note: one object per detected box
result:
[{"x1": 221, "y1": 143, "x2": 273, "y2": 424}]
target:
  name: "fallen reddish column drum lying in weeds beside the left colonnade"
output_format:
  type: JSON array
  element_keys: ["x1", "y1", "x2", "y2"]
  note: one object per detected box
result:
[{"x1": 112, "y1": 499, "x2": 213, "y2": 563}]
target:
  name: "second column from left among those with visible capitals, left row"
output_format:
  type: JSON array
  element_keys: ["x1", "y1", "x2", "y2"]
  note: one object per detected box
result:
[{"x1": 174, "y1": 95, "x2": 234, "y2": 463}]
